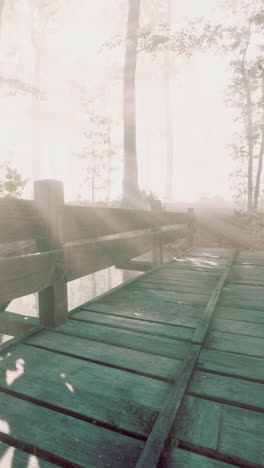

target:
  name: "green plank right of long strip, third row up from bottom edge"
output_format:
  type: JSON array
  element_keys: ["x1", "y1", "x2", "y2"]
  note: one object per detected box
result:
[{"x1": 188, "y1": 371, "x2": 264, "y2": 410}]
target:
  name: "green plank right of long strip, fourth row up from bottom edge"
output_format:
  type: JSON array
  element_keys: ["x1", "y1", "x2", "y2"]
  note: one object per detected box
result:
[{"x1": 198, "y1": 349, "x2": 264, "y2": 382}]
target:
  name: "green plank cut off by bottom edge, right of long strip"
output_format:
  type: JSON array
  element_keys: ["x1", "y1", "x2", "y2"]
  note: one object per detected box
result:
[{"x1": 164, "y1": 449, "x2": 235, "y2": 468}]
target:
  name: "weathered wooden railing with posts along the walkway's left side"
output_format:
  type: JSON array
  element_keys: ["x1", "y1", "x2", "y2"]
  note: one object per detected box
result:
[{"x1": 0, "y1": 180, "x2": 194, "y2": 328}]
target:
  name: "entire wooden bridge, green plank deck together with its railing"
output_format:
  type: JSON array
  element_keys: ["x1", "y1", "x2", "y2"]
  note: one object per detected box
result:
[{"x1": 0, "y1": 182, "x2": 264, "y2": 468}]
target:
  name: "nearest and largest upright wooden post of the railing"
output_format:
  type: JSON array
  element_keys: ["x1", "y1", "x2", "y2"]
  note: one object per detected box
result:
[{"x1": 34, "y1": 180, "x2": 68, "y2": 328}]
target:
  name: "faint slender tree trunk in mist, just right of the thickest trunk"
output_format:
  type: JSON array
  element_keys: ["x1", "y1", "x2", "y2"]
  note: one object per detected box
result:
[{"x1": 164, "y1": 0, "x2": 174, "y2": 200}]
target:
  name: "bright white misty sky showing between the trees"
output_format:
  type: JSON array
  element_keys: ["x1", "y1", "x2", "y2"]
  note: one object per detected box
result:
[{"x1": 0, "y1": 0, "x2": 235, "y2": 201}]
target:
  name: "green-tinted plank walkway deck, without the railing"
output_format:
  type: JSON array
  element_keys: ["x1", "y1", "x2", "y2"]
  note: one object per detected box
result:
[{"x1": 0, "y1": 249, "x2": 264, "y2": 468}]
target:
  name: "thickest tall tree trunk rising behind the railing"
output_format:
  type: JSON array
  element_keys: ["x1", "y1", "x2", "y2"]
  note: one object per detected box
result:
[{"x1": 123, "y1": 0, "x2": 140, "y2": 206}]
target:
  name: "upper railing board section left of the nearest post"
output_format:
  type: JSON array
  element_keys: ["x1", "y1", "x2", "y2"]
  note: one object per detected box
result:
[{"x1": 0, "y1": 198, "x2": 44, "y2": 243}]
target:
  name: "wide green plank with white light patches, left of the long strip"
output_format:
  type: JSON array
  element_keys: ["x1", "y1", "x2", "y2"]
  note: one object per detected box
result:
[{"x1": 0, "y1": 345, "x2": 169, "y2": 436}]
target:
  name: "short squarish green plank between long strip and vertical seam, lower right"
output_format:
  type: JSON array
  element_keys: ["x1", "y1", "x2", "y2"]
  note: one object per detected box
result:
[{"x1": 171, "y1": 396, "x2": 222, "y2": 450}]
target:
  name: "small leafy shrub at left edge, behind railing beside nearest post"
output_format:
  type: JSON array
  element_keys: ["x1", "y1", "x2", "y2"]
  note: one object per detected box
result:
[{"x1": 0, "y1": 162, "x2": 28, "y2": 197}]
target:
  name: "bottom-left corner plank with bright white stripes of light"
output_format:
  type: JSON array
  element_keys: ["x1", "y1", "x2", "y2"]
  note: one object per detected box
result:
[{"x1": 0, "y1": 442, "x2": 58, "y2": 468}]
